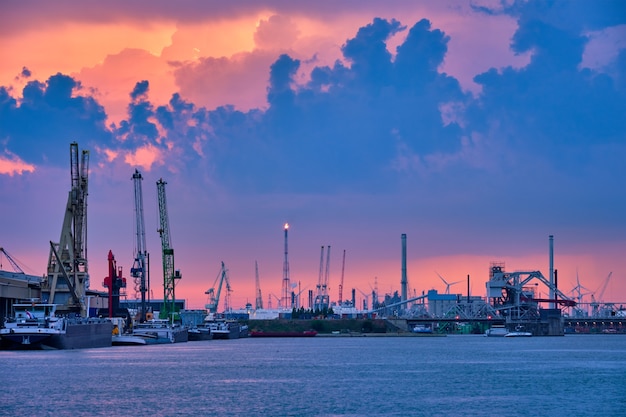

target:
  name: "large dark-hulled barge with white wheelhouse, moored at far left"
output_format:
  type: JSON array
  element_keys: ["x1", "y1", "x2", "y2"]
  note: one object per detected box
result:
[{"x1": 0, "y1": 302, "x2": 113, "y2": 349}]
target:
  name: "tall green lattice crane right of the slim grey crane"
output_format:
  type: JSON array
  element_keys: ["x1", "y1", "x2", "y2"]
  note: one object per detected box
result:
[{"x1": 157, "y1": 178, "x2": 182, "y2": 319}]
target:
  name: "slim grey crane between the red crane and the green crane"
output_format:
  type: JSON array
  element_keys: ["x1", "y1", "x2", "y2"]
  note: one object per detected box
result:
[{"x1": 130, "y1": 170, "x2": 148, "y2": 323}]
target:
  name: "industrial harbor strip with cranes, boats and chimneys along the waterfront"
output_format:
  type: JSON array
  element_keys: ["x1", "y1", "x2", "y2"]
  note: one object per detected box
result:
[{"x1": 0, "y1": 143, "x2": 626, "y2": 349}]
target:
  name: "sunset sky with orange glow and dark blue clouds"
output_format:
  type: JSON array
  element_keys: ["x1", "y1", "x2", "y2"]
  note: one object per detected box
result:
[{"x1": 0, "y1": 0, "x2": 626, "y2": 308}]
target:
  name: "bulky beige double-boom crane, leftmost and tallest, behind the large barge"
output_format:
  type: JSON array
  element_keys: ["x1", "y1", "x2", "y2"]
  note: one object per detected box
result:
[{"x1": 41, "y1": 142, "x2": 89, "y2": 317}]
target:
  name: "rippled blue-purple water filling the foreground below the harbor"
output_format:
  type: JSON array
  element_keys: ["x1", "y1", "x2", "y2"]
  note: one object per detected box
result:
[{"x1": 0, "y1": 335, "x2": 626, "y2": 417}]
